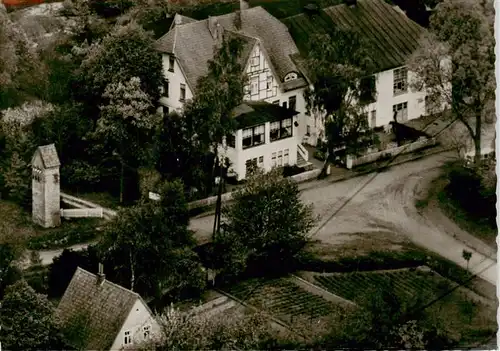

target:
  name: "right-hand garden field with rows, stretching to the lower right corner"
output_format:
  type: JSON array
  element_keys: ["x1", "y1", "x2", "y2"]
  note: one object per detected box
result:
[{"x1": 300, "y1": 267, "x2": 497, "y2": 346}]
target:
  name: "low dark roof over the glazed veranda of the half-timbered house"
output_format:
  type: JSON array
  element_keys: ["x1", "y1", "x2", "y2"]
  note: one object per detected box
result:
[{"x1": 232, "y1": 101, "x2": 298, "y2": 129}]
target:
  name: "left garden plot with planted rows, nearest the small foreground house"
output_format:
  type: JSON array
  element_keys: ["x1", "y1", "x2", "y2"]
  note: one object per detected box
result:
[{"x1": 227, "y1": 278, "x2": 343, "y2": 327}]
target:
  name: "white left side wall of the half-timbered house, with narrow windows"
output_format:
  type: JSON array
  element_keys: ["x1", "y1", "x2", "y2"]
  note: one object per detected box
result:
[{"x1": 160, "y1": 54, "x2": 193, "y2": 112}]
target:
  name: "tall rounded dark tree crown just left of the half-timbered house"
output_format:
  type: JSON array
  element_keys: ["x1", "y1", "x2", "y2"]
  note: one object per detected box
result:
[{"x1": 74, "y1": 23, "x2": 163, "y2": 118}]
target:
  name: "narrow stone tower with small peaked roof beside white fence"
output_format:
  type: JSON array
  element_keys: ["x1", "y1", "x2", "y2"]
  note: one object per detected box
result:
[{"x1": 31, "y1": 144, "x2": 61, "y2": 228}]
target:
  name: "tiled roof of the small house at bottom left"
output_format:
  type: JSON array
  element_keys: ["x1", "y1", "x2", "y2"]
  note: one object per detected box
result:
[{"x1": 56, "y1": 267, "x2": 147, "y2": 350}]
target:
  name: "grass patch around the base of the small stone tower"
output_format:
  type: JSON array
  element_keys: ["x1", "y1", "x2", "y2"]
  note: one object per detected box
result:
[{"x1": 0, "y1": 200, "x2": 103, "y2": 250}]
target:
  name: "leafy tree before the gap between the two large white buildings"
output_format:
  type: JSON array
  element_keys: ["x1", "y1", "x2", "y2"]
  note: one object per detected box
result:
[{"x1": 305, "y1": 27, "x2": 375, "y2": 177}]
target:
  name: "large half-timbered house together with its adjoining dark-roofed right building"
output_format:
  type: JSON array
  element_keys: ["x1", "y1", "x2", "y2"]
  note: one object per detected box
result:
[{"x1": 156, "y1": 0, "x2": 429, "y2": 180}]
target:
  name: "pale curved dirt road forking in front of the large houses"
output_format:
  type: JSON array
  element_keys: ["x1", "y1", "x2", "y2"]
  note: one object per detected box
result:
[{"x1": 190, "y1": 152, "x2": 497, "y2": 285}]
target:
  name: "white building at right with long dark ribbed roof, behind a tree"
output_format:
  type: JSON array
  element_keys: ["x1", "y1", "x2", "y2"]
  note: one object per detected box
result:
[{"x1": 283, "y1": 0, "x2": 440, "y2": 144}]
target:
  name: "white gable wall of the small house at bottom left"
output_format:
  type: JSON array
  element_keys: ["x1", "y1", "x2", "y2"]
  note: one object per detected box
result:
[{"x1": 111, "y1": 299, "x2": 160, "y2": 350}]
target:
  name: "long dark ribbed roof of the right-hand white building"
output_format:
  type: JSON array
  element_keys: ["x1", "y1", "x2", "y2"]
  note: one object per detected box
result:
[{"x1": 283, "y1": 0, "x2": 425, "y2": 72}]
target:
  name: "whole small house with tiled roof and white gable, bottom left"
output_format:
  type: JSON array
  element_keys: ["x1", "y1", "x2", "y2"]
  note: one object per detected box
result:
[{"x1": 56, "y1": 267, "x2": 160, "y2": 350}]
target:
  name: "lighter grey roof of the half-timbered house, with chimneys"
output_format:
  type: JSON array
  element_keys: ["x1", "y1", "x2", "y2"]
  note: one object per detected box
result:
[{"x1": 156, "y1": 6, "x2": 299, "y2": 92}]
